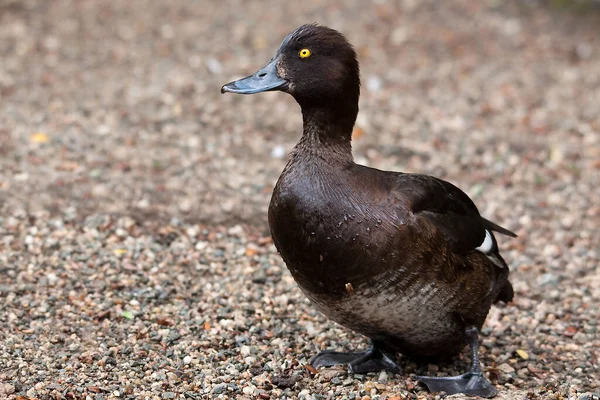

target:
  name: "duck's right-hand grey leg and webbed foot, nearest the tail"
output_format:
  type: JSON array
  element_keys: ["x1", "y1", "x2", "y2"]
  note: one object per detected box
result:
[{"x1": 417, "y1": 328, "x2": 498, "y2": 398}]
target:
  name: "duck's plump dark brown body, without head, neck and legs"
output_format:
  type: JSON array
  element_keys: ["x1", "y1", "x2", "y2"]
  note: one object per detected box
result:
[{"x1": 269, "y1": 163, "x2": 509, "y2": 355}]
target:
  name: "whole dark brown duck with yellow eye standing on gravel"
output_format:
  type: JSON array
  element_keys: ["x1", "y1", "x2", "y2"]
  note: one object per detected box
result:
[{"x1": 221, "y1": 24, "x2": 516, "y2": 397}]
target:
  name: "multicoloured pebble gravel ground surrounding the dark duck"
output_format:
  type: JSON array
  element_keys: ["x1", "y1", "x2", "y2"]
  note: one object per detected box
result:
[{"x1": 0, "y1": 0, "x2": 600, "y2": 400}]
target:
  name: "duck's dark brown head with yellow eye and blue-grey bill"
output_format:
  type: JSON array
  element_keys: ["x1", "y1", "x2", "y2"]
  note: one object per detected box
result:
[{"x1": 221, "y1": 25, "x2": 360, "y2": 110}]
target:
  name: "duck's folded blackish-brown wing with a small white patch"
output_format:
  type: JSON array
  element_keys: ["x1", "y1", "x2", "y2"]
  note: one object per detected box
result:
[{"x1": 396, "y1": 174, "x2": 517, "y2": 268}]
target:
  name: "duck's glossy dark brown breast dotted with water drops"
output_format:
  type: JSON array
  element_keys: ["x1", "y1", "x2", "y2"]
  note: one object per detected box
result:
[{"x1": 269, "y1": 164, "x2": 406, "y2": 295}]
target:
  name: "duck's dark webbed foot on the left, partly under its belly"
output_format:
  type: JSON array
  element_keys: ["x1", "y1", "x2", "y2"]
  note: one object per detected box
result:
[{"x1": 310, "y1": 341, "x2": 402, "y2": 374}]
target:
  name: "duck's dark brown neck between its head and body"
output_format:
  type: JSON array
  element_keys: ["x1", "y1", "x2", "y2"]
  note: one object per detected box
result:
[{"x1": 294, "y1": 104, "x2": 358, "y2": 164}]
